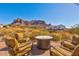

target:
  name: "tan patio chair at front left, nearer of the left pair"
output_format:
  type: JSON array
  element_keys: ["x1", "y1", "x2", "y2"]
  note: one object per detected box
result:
[{"x1": 5, "y1": 38, "x2": 32, "y2": 56}]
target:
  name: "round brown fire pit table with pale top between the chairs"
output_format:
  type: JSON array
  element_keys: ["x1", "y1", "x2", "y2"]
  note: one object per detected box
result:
[{"x1": 35, "y1": 36, "x2": 53, "y2": 50}]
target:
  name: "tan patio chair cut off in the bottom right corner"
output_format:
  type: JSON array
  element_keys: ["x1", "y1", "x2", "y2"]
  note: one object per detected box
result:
[{"x1": 50, "y1": 45, "x2": 79, "y2": 56}]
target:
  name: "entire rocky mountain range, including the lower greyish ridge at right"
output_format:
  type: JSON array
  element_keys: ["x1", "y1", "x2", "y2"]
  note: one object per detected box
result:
[{"x1": 12, "y1": 18, "x2": 66, "y2": 30}]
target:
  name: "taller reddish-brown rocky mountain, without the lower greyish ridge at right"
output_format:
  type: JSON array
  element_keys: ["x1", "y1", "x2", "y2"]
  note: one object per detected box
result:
[{"x1": 11, "y1": 18, "x2": 47, "y2": 26}]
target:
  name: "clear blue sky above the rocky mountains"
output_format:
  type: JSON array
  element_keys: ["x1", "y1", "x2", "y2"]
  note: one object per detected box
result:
[{"x1": 0, "y1": 3, "x2": 79, "y2": 27}]
